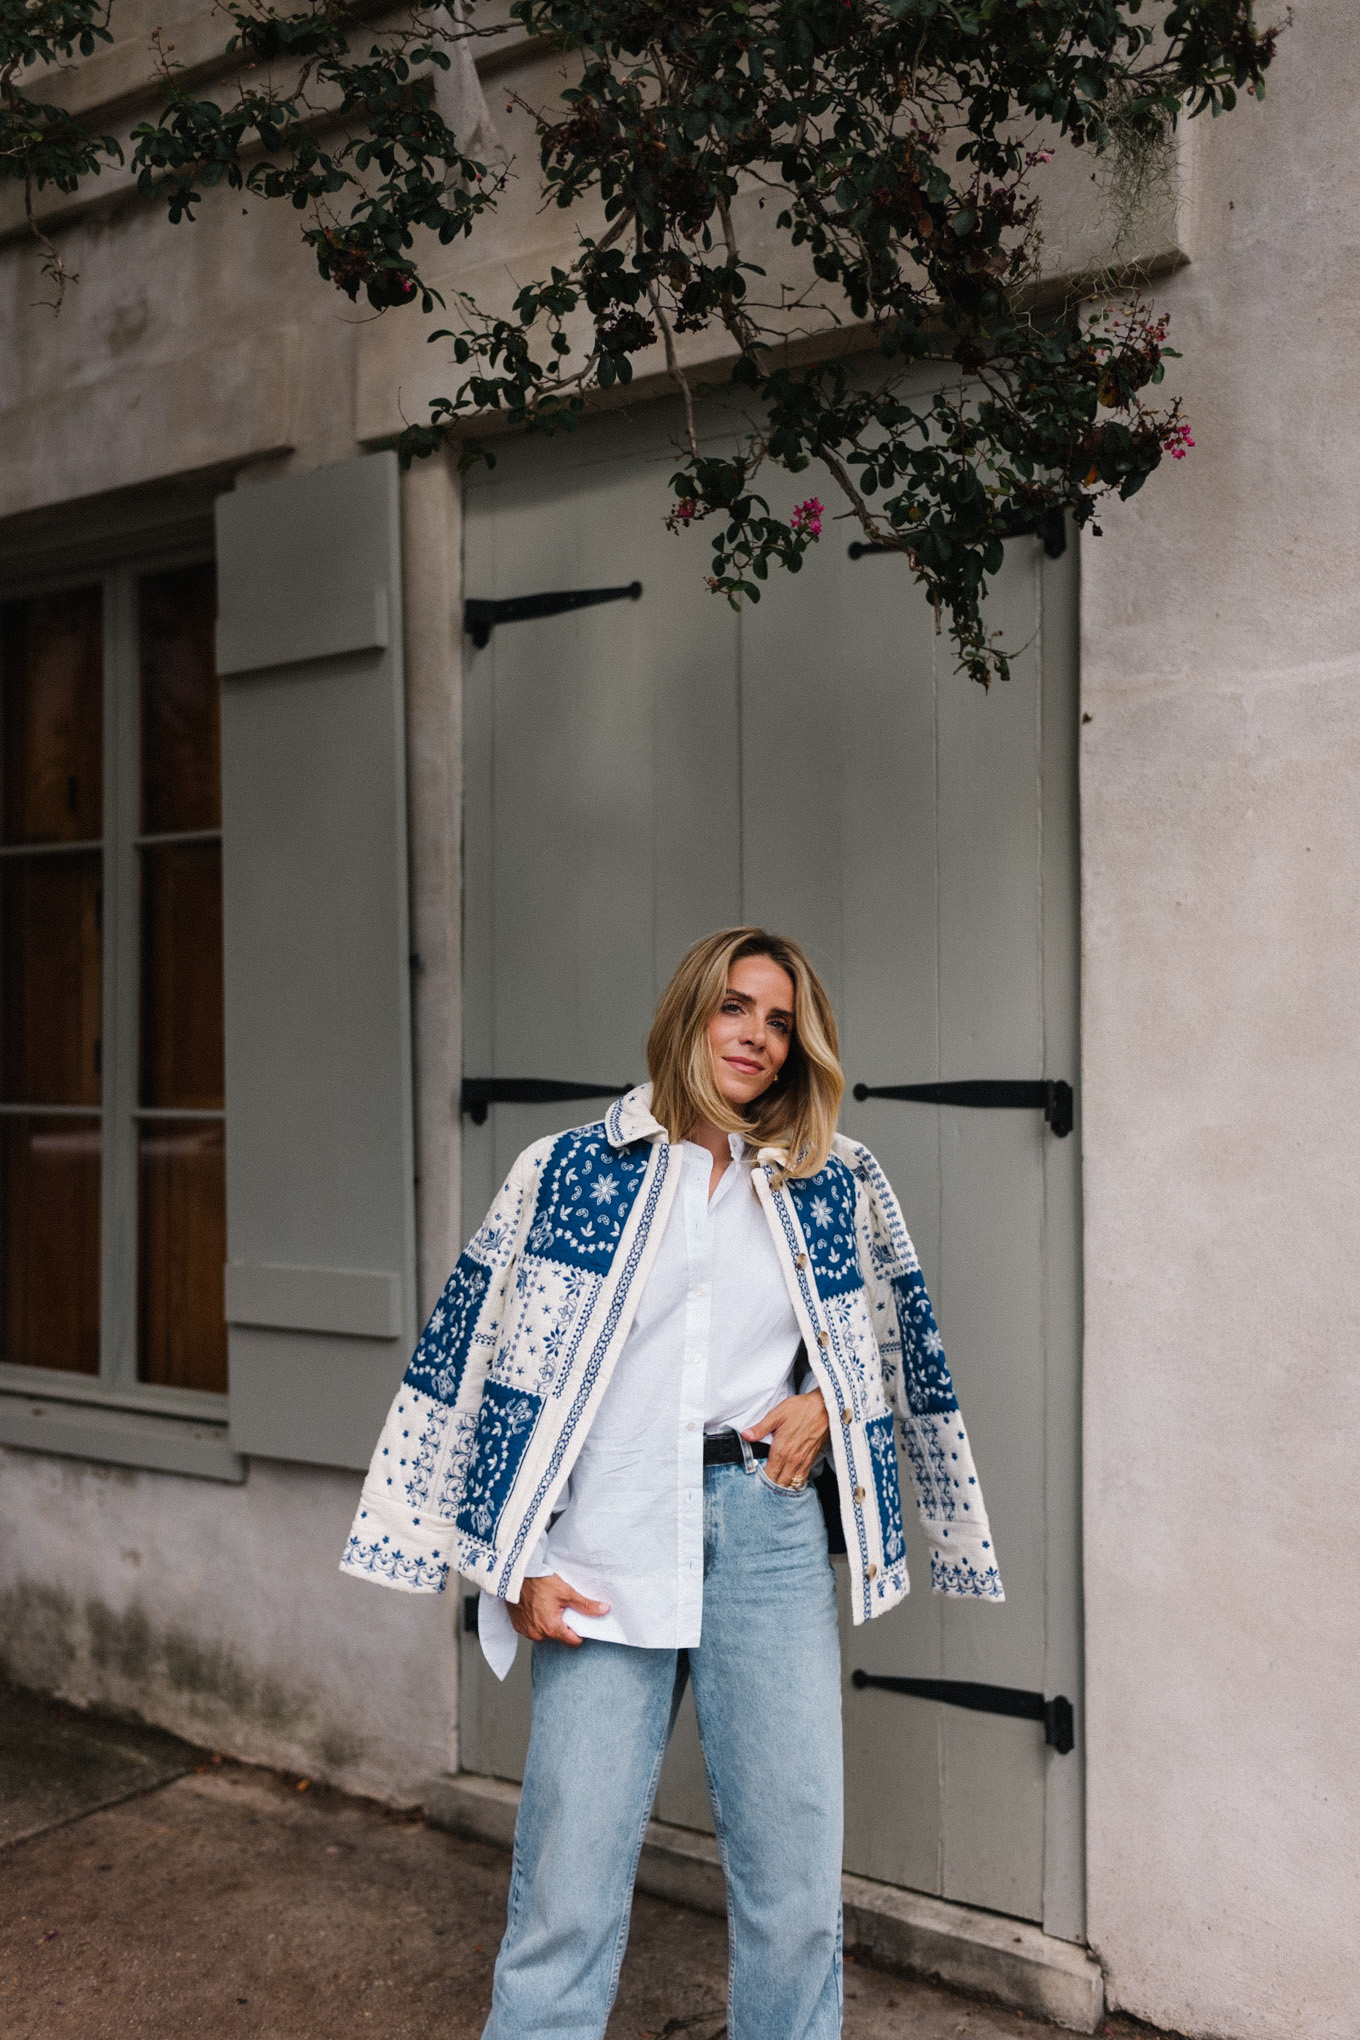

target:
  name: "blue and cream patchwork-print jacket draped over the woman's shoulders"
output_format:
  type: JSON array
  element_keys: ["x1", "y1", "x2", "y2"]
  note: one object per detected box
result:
[{"x1": 341, "y1": 1085, "x2": 1003, "y2": 1622}]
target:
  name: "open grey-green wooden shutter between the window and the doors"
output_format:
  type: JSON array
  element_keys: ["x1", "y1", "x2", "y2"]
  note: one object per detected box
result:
[{"x1": 216, "y1": 453, "x2": 416, "y2": 1467}]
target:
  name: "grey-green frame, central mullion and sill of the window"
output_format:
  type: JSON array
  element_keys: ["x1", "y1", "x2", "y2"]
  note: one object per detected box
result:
[{"x1": 0, "y1": 526, "x2": 245, "y2": 1481}]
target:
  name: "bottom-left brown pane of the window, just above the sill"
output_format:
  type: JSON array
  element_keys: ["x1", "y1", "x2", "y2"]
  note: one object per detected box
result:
[{"x1": 0, "y1": 1114, "x2": 100, "y2": 1375}]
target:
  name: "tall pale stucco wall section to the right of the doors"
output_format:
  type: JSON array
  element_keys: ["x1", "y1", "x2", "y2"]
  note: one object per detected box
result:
[{"x1": 1083, "y1": 0, "x2": 1360, "y2": 2040}]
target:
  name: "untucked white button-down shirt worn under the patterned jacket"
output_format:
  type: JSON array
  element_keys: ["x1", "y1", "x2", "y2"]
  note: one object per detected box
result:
[{"x1": 477, "y1": 1134, "x2": 799, "y2": 1679}]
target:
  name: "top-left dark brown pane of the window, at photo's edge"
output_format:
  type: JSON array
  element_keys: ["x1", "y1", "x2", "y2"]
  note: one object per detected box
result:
[{"x1": 0, "y1": 588, "x2": 104, "y2": 843}]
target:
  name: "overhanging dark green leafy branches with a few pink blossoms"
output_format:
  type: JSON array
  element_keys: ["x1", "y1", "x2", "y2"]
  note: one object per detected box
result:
[{"x1": 0, "y1": 0, "x2": 1289, "y2": 685}]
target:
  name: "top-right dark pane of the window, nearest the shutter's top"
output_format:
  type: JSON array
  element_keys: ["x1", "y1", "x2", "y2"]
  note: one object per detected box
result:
[{"x1": 139, "y1": 567, "x2": 222, "y2": 836}]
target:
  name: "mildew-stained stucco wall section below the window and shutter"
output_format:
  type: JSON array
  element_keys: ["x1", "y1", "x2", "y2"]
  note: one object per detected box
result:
[{"x1": 0, "y1": 1446, "x2": 457, "y2": 1803}]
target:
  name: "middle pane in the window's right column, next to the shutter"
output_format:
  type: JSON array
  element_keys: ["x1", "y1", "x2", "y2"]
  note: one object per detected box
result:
[{"x1": 141, "y1": 843, "x2": 222, "y2": 1112}]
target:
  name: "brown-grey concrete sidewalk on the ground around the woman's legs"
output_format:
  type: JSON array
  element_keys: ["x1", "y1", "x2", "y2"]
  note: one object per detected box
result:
[{"x1": 0, "y1": 1689, "x2": 1156, "y2": 2040}]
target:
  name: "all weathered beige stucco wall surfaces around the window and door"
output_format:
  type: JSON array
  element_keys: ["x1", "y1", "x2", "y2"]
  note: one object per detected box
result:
[{"x1": 0, "y1": 0, "x2": 1360, "y2": 2015}]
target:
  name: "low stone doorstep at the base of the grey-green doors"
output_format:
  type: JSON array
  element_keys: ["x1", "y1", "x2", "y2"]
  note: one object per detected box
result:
[{"x1": 424, "y1": 1773, "x2": 1105, "y2": 2034}]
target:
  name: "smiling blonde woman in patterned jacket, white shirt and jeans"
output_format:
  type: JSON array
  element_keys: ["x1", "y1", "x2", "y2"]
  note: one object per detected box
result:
[{"x1": 343, "y1": 928, "x2": 1001, "y2": 2040}]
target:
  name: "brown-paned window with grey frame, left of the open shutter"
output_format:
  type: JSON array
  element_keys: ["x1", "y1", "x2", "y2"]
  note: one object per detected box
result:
[{"x1": 0, "y1": 563, "x2": 226, "y2": 1412}]
